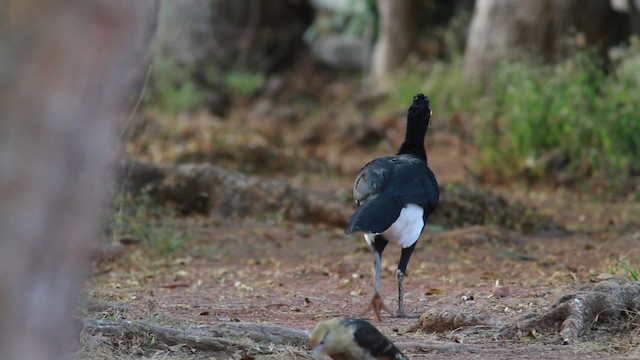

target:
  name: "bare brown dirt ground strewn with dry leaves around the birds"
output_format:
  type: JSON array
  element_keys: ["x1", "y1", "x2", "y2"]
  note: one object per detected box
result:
[{"x1": 79, "y1": 83, "x2": 640, "y2": 359}]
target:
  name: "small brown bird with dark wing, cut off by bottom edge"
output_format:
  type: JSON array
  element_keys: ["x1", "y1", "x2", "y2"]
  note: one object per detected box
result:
[{"x1": 310, "y1": 317, "x2": 407, "y2": 360}]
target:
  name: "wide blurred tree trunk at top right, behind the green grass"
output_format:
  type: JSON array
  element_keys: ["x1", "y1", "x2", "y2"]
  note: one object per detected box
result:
[{"x1": 465, "y1": 0, "x2": 623, "y2": 80}]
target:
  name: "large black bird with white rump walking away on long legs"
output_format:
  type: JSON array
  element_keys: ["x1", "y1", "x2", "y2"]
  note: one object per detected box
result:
[{"x1": 345, "y1": 94, "x2": 440, "y2": 321}]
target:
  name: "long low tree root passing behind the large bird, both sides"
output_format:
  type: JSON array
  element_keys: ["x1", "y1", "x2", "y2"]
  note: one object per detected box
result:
[{"x1": 117, "y1": 160, "x2": 562, "y2": 233}]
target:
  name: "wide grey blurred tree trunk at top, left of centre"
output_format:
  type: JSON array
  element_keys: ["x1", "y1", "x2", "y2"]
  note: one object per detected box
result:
[{"x1": 158, "y1": 0, "x2": 314, "y2": 75}]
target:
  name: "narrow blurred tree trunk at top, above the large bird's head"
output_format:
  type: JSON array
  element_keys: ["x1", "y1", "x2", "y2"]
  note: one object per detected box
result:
[{"x1": 371, "y1": 0, "x2": 420, "y2": 87}]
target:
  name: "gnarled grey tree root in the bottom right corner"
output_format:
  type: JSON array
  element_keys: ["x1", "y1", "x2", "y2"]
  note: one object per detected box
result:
[{"x1": 498, "y1": 281, "x2": 640, "y2": 344}]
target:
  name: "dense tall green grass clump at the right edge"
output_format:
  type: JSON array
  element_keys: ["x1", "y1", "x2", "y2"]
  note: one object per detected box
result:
[{"x1": 475, "y1": 48, "x2": 640, "y2": 185}]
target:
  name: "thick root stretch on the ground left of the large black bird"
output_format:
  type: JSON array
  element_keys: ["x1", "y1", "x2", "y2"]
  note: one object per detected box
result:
[{"x1": 118, "y1": 161, "x2": 351, "y2": 226}]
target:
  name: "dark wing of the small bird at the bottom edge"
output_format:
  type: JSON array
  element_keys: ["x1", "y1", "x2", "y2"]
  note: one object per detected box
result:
[{"x1": 348, "y1": 319, "x2": 406, "y2": 360}]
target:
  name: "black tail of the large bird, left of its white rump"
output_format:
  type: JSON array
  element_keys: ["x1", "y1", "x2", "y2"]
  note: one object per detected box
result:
[{"x1": 344, "y1": 195, "x2": 402, "y2": 235}]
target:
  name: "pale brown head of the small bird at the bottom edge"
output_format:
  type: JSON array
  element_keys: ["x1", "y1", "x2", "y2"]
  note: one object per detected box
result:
[{"x1": 310, "y1": 318, "x2": 353, "y2": 355}]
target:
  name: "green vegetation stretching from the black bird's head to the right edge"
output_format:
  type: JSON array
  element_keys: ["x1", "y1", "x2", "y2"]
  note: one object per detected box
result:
[{"x1": 384, "y1": 44, "x2": 640, "y2": 187}]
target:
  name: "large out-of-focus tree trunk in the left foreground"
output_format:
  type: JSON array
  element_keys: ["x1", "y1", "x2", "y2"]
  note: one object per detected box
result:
[{"x1": 0, "y1": 0, "x2": 157, "y2": 360}]
